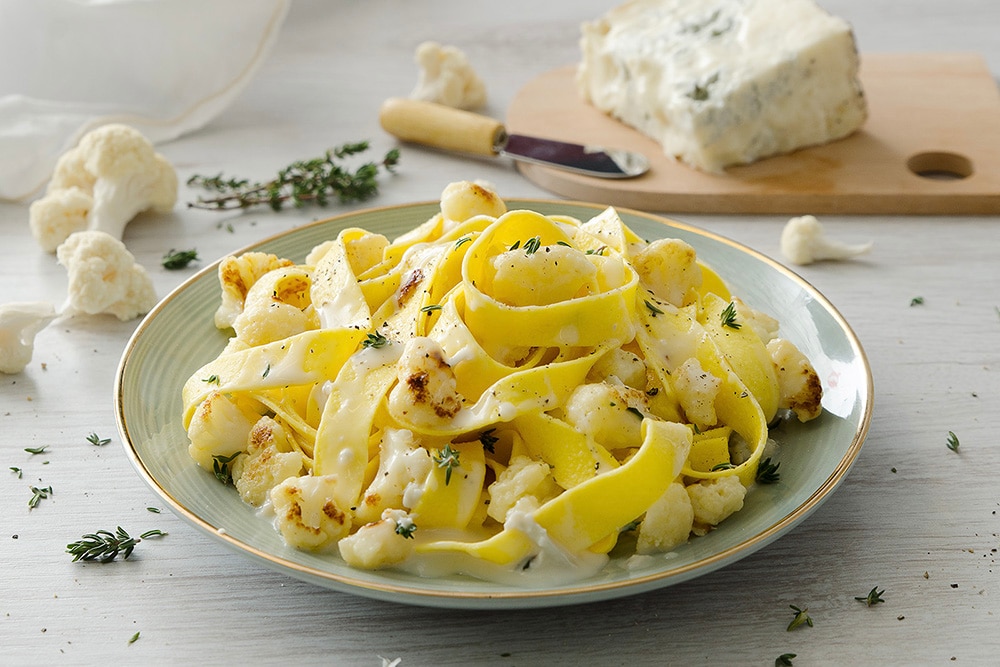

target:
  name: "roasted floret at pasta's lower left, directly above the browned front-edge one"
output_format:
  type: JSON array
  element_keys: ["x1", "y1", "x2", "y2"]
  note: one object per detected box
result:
[{"x1": 232, "y1": 417, "x2": 303, "y2": 506}]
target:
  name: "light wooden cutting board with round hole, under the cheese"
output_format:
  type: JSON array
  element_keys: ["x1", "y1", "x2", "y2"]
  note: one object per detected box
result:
[{"x1": 506, "y1": 54, "x2": 1000, "y2": 215}]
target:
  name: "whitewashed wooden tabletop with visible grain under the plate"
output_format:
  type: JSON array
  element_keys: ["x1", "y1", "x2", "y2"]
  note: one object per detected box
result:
[{"x1": 0, "y1": 0, "x2": 1000, "y2": 666}]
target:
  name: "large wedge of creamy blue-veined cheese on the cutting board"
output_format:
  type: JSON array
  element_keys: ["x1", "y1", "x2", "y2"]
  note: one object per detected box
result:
[{"x1": 577, "y1": 0, "x2": 867, "y2": 172}]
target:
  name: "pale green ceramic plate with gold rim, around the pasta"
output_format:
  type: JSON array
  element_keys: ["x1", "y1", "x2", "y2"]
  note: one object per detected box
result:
[{"x1": 115, "y1": 200, "x2": 872, "y2": 609}]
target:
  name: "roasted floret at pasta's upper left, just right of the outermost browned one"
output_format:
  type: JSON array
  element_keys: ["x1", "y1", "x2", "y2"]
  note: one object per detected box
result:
[{"x1": 233, "y1": 266, "x2": 319, "y2": 346}]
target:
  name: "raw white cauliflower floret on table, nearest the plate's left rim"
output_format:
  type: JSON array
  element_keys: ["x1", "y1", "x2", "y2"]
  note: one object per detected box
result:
[{"x1": 56, "y1": 231, "x2": 156, "y2": 321}]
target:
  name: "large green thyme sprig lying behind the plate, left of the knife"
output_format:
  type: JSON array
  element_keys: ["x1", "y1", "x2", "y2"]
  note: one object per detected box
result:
[{"x1": 187, "y1": 141, "x2": 399, "y2": 211}]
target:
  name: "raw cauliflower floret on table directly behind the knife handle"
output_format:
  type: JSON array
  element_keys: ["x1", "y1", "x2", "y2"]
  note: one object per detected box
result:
[{"x1": 410, "y1": 42, "x2": 486, "y2": 109}]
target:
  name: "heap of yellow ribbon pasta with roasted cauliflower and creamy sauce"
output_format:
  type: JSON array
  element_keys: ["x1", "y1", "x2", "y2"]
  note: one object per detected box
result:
[{"x1": 183, "y1": 182, "x2": 822, "y2": 583}]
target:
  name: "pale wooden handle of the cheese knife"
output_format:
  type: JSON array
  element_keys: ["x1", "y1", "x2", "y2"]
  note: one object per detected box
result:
[{"x1": 379, "y1": 97, "x2": 507, "y2": 155}]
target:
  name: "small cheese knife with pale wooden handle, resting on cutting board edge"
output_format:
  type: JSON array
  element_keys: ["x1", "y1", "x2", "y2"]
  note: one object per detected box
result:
[{"x1": 379, "y1": 97, "x2": 649, "y2": 178}]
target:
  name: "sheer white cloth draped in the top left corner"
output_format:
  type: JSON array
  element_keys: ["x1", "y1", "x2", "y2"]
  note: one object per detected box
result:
[{"x1": 0, "y1": 0, "x2": 290, "y2": 199}]
